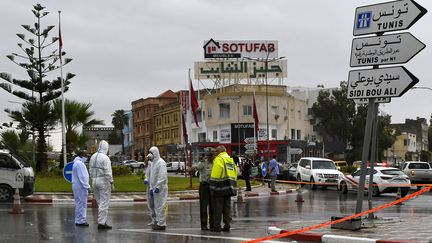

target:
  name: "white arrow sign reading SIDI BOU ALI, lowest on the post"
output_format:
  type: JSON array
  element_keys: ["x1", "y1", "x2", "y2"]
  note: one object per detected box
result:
[{"x1": 348, "y1": 66, "x2": 419, "y2": 99}]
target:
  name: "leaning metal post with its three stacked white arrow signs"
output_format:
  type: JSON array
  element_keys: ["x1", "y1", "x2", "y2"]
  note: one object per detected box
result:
[{"x1": 343, "y1": 0, "x2": 427, "y2": 230}]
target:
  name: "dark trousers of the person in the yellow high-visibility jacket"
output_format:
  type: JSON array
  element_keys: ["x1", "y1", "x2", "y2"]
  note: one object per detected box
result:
[{"x1": 212, "y1": 195, "x2": 232, "y2": 229}]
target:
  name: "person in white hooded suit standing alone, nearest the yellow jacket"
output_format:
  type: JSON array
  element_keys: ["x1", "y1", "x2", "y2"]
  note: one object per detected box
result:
[{"x1": 144, "y1": 147, "x2": 168, "y2": 230}]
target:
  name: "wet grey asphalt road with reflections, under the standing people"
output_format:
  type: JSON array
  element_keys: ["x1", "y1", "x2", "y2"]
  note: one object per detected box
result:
[{"x1": 0, "y1": 189, "x2": 432, "y2": 243}]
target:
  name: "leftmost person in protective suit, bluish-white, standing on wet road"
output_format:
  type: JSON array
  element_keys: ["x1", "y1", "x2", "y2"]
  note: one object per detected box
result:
[{"x1": 72, "y1": 150, "x2": 90, "y2": 227}]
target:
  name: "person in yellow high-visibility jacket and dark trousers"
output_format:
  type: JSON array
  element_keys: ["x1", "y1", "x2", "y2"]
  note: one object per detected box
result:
[{"x1": 210, "y1": 146, "x2": 237, "y2": 232}]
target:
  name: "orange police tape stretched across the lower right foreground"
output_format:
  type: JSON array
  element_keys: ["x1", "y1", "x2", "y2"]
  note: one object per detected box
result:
[{"x1": 243, "y1": 186, "x2": 432, "y2": 243}]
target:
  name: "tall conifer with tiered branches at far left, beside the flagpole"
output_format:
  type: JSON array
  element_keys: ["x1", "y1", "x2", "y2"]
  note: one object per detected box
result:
[{"x1": 0, "y1": 4, "x2": 75, "y2": 171}]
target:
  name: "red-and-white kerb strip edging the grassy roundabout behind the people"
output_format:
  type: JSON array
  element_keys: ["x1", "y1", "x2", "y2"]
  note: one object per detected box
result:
[{"x1": 25, "y1": 184, "x2": 296, "y2": 204}]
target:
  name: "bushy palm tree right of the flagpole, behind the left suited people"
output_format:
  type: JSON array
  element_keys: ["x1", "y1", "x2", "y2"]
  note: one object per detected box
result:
[{"x1": 54, "y1": 99, "x2": 104, "y2": 167}]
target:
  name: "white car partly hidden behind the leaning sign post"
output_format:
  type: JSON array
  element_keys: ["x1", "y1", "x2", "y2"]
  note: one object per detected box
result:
[{"x1": 338, "y1": 167, "x2": 411, "y2": 197}]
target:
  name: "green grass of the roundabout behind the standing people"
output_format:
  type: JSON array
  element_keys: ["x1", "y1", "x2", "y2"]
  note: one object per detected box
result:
[{"x1": 35, "y1": 175, "x2": 259, "y2": 192}]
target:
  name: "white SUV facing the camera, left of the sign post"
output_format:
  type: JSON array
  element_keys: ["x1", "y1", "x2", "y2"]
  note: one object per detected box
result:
[{"x1": 297, "y1": 157, "x2": 343, "y2": 190}]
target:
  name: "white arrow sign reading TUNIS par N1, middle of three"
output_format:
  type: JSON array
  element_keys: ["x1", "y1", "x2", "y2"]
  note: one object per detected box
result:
[{"x1": 350, "y1": 33, "x2": 426, "y2": 67}]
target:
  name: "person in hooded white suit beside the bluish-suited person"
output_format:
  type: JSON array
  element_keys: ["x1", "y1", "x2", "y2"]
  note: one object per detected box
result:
[{"x1": 90, "y1": 140, "x2": 114, "y2": 229}]
